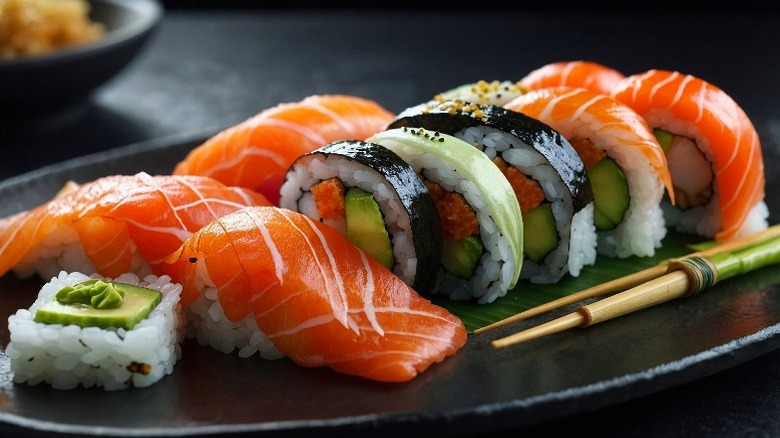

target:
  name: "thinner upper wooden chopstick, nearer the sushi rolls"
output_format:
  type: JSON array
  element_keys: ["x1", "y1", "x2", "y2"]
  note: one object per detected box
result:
[{"x1": 474, "y1": 224, "x2": 780, "y2": 333}]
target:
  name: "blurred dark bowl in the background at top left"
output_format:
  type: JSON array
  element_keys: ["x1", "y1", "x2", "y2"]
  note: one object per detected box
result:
[{"x1": 0, "y1": 0, "x2": 163, "y2": 118}]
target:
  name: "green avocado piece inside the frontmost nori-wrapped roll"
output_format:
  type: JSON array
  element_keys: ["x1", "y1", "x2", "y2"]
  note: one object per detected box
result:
[{"x1": 344, "y1": 187, "x2": 395, "y2": 269}]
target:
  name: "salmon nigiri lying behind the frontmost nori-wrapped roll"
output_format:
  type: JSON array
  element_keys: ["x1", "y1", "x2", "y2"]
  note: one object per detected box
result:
[{"x1": 173, "y1": 94, "x2": 393, "y2": 205}]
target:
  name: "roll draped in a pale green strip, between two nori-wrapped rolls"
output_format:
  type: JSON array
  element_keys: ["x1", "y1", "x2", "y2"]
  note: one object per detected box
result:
[{"x1": 366, "y1": 128, "x2": 523, "y2": 304}]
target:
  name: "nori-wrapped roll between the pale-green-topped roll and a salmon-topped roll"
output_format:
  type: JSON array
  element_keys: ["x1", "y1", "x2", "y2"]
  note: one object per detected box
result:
[{"x1": 390, "y1": 101, "x2": 596, "y2": 283}]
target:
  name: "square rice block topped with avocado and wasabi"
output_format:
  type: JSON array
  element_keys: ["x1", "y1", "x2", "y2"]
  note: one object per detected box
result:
[{"x1": 6, "y1": 271, "x2": 185, "y2": 391}]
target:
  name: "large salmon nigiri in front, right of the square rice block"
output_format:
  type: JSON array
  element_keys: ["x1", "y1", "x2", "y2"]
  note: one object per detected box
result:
[{"x1": 169, "y1": 207, "x2": 467, "y2": 382}]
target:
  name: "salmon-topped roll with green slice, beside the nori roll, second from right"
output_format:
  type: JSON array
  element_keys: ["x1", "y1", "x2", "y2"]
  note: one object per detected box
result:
[{"x1": 506, "y1": 87, "x2": 674, "y2": 257}]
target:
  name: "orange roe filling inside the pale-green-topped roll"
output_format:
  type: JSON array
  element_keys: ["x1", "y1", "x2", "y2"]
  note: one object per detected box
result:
[{"x1": 425, "y1": 180, "x2": 479, "y2": 239}]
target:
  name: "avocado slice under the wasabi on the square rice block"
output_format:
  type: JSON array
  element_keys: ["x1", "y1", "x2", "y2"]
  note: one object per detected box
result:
[{"x1": 34, "y1": 280, "x2": 162, "y2": 330}]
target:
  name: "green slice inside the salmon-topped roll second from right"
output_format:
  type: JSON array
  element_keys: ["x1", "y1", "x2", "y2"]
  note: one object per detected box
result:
[{"x1": 588, "y1": 157, "x2": 629, "y2": 230}]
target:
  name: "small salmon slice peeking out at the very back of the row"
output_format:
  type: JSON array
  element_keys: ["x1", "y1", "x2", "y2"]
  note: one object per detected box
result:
[{"x1": 518, "y1": 61, "x2": 625, "y2": 94}]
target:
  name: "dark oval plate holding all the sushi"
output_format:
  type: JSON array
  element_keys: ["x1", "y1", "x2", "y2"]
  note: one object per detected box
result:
[{"x1": 0, "y1": 132, "x2": 780, "y2": 437}]
